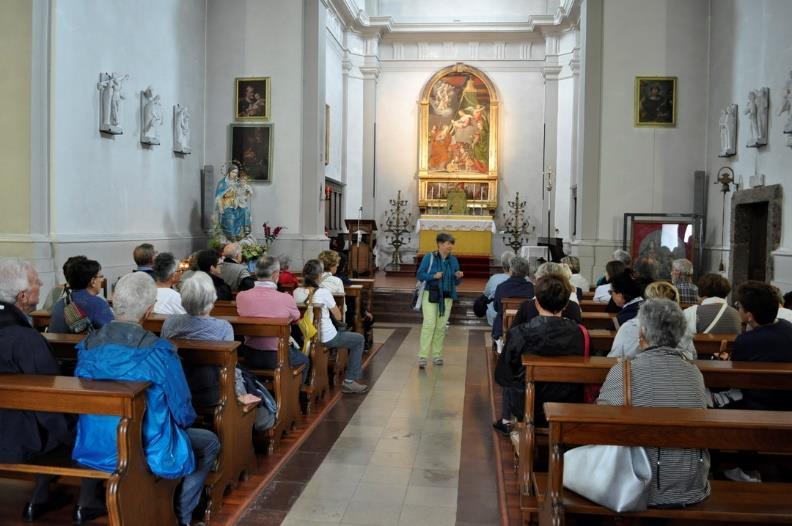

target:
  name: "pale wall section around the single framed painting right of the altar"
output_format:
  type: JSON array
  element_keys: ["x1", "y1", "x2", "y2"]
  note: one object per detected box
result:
[{"x1": 596, "y1": 0, "x2": 715, "y2": 241}]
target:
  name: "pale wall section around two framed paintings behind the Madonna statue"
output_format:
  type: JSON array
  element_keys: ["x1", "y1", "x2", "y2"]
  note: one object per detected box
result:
[{"x1": 204, "y1": 0, "x2": 303, "y2": 238}]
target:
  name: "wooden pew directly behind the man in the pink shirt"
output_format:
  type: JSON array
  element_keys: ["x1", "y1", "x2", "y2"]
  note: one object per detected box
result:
[{"x1": 143, "y1": 314, "x2": 305, "y2": 454}]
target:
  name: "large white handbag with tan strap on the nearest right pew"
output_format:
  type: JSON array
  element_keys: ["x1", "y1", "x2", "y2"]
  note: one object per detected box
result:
[{"x1": 564, "y1": 360, "x2": 652, "y2": 513}]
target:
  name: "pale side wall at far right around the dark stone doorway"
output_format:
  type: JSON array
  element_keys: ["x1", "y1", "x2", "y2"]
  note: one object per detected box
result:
[{"x1": 707, "y1": 0, "x2": 792, "y2": 291}]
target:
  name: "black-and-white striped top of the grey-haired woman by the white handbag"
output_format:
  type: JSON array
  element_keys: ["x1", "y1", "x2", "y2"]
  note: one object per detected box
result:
[{"x1": 597, "y1": 347, "x2": 710, "y2": 506}]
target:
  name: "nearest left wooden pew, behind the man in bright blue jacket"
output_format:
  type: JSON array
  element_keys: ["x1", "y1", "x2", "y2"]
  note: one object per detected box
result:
[{"x1": 0, "y1": 375, "x2": 179, "y2": 526}]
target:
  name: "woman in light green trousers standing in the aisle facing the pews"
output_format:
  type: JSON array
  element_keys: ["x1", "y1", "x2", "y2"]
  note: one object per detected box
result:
[{"x1": 418, "y1": 232, "x2": 463, "y2": 369}]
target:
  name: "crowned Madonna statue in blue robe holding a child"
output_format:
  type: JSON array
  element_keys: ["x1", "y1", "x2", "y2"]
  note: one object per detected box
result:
[{"x1": 215, "y1": 163, "x2": 253, "y2": 243}]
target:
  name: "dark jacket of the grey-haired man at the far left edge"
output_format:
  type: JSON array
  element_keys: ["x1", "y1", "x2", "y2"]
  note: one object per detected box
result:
[{"x1": 0, "y1": 303, "x2": 73, "y2": 463}]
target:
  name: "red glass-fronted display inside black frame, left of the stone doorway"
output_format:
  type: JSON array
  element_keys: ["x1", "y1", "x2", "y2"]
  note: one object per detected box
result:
[{"x1": 630, "y1": 219, "x2": 696, "y2": 279}]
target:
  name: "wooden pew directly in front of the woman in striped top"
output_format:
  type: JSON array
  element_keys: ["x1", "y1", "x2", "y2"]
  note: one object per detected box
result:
[{"x1": 518, "y1": 354, "x2": 792, "y2": 516}]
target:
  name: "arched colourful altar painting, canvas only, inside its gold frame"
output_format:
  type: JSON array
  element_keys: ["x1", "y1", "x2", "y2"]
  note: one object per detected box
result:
[{"x1": 428, "y1": 73, "x2": 490, "y2": 173}]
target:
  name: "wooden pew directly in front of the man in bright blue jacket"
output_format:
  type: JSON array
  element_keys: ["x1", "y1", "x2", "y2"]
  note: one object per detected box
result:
[{"x1": 43, "y1": 333, "x2": 256, "y2": 521}]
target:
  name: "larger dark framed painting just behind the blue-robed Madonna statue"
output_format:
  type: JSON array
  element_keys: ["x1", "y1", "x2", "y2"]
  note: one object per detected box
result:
[{"x1": 229, "y1": 124, "x2": 273, "y2": 183}]
